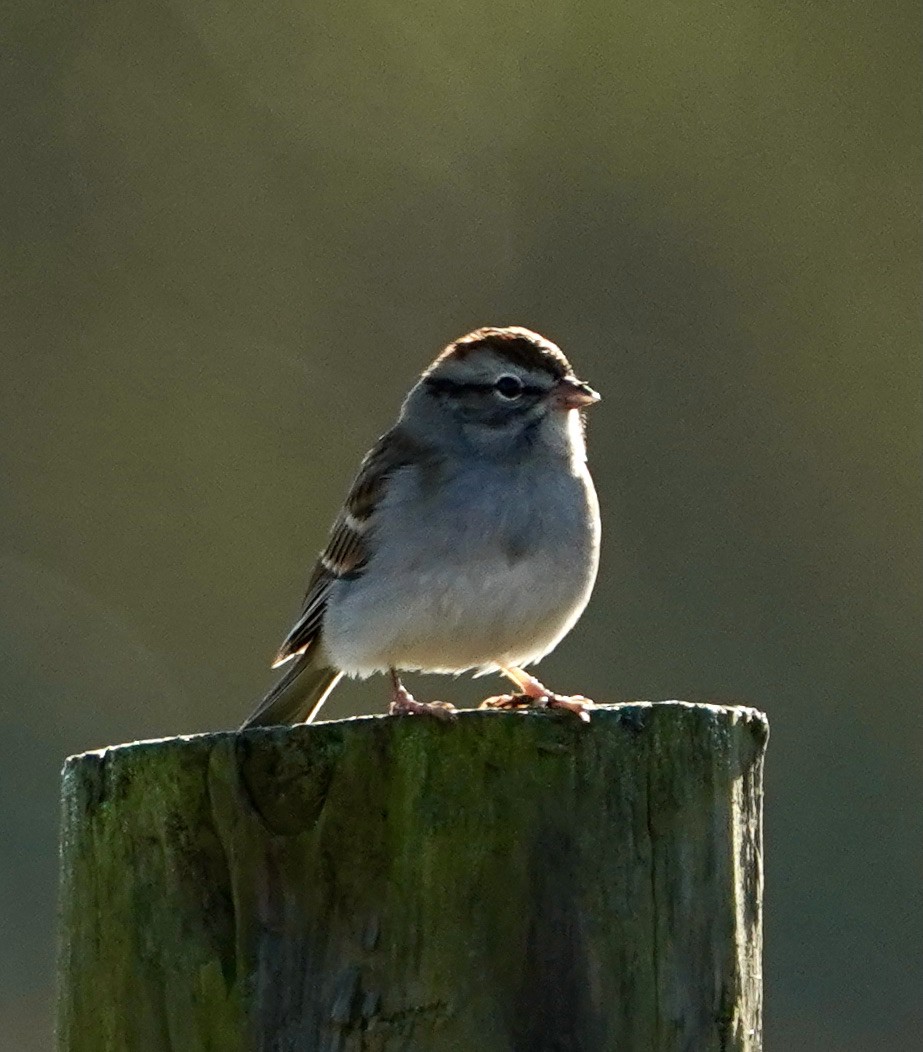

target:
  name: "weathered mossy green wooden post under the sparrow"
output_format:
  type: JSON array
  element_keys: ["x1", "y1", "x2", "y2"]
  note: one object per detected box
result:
[{"x1": 59, "y1": 702, "x2": 767, "y2": 1052}]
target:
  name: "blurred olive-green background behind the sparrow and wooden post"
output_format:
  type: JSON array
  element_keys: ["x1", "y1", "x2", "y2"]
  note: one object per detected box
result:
[{"x1": 0, "y1": 0, "x2": 923, "y2": 1052}]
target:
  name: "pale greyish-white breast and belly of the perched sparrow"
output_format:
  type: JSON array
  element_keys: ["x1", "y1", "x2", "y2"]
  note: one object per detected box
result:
[{"x1": 324, "y1": 461, "x2": 599, "y2": 675}]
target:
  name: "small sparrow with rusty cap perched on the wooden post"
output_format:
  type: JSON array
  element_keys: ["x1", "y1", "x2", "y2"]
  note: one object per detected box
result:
[{"x1": 241, "y1": 325, "x2": 601, "y2": 729}]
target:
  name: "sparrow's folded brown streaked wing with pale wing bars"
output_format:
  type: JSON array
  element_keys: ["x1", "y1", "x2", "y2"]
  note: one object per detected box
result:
[{"x1": 273, "y1": 427, "x2": 423, "y2": 668}]
